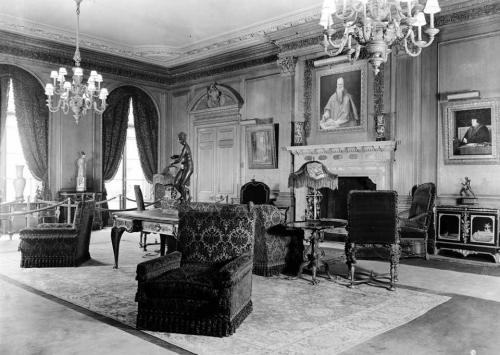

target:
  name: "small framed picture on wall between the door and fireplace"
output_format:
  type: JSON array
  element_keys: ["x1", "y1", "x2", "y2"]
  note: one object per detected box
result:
[{"x1": 246, "y1": 124, "x2": 278, "y2": 169}]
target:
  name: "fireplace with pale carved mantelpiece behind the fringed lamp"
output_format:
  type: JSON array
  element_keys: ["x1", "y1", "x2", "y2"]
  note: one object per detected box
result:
[{"x1": 286, "y1": 141, "x2": 396, "y2": 220}]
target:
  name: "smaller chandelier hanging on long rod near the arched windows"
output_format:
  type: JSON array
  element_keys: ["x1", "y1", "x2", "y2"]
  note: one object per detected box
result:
[{"x1": 45, "y1": 0, "x2": 108, "y2": 124}]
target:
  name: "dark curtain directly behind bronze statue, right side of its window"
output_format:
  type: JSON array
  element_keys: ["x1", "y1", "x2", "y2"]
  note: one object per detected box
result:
[{"x1": 132, "y1": 89, "x2": 158, "y2": 183}]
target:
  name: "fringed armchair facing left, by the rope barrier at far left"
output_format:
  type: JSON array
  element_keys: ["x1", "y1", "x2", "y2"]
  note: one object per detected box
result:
[{"x1": 19, "y1": 200, "x2": 95, "y2": 267}]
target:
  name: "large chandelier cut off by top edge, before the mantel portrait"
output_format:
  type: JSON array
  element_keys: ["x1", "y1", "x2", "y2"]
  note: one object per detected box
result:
[{"x1": 320, "y1": 0, "x2": 441, "y2": 74}]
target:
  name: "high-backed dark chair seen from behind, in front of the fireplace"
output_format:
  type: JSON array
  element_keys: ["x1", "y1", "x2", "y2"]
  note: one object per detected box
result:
[{"x1": 345, "y1": 190, "x2": 400, "y2": 290}]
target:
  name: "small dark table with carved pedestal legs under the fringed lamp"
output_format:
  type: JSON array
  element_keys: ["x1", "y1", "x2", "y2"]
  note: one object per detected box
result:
[{"x1": 287, "y1": 218, "x2": 347, "y2": 285}]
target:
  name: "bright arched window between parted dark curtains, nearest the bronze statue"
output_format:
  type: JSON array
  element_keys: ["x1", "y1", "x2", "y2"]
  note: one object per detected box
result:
[{"x1": 106, "y1": 99, "x2": 153, "y2": 209}]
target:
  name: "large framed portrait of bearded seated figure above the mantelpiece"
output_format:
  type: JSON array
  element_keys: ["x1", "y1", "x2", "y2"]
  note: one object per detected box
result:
[{"x1": 314, "y1": 61, "x2": 367, "y2": 132}]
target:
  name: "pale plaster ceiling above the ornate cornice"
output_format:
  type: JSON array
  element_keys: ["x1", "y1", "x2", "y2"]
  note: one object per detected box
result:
[{"x1": 0, "y1": 0, "x2": 490, "y2": 68}]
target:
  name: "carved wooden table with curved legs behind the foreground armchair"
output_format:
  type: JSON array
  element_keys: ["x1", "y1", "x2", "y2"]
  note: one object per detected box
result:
[{"x1": 111, "y1": 208, "x2": 179, "y2": 269}]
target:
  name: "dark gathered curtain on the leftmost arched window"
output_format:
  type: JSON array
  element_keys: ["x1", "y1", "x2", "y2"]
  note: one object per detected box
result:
[{"x1": 0, "y1": 65, "x2": 49, "y2": 193}]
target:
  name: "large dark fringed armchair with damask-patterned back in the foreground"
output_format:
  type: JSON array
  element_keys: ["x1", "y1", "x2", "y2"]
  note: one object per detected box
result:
[{"x1": 136, "y1": 205, "x2": 255, "y2": 337}]
